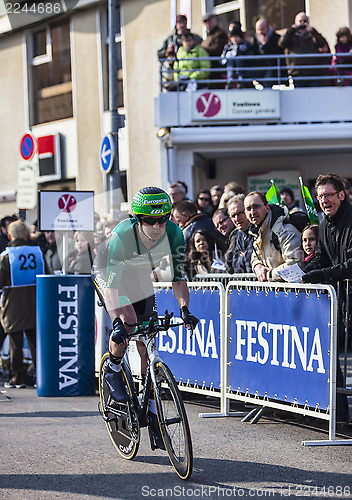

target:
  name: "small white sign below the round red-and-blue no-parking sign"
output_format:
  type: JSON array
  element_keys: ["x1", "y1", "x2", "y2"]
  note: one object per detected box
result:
[{"x1": 16, "y1": 161, "x2": 38, "y2": 210}]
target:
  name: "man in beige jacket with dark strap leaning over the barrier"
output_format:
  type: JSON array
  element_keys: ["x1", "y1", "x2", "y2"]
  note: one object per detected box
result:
[{"x1": 244, "y1": 191, "x2": 302, "y2": 281}]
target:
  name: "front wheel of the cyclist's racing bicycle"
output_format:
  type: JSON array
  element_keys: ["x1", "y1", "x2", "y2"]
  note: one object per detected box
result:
[{"x1": 154, "y1": 362, "x2": 193, "y2": 480}]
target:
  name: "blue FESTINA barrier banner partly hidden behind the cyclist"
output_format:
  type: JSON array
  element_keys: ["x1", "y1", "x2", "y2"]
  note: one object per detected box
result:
[{"x1": 155, "y1": 288, "x2": 220, "y2": 389}]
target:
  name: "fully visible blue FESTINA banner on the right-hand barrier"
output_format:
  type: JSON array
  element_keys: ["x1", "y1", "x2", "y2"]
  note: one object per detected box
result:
[{"x1": 229, "y1": 290, "x2": 331, "y2": 410}]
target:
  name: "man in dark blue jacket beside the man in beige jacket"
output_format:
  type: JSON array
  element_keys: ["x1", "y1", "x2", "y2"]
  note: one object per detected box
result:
[{"x1": 225, "y1": 194, "x2": 253, "y2": 274}]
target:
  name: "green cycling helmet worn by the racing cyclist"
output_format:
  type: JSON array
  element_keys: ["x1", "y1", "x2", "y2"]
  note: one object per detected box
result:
[{"x1": 132, "y1": 186, "x2": 172, "y2": 220}]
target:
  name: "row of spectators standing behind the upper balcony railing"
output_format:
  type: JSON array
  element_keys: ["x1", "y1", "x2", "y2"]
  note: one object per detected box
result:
[{"x1": 158, "y1": 12, "x2": 352, "y2": 91}]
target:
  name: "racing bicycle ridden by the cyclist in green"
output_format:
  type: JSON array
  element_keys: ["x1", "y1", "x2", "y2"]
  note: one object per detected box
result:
[{"x1": 99, "y1": 311, "x2": 193, "y2": 480}]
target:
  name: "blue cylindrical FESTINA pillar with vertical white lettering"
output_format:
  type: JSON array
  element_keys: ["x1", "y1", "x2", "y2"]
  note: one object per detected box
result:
[{"x1": 37, "y1": 275, "x2": 95, "y2": 396}]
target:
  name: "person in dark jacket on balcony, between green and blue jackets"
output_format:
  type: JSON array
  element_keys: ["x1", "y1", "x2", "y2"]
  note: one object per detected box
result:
[{"x1": 201, "y1": 13, "x2": 228, "y2": 88}]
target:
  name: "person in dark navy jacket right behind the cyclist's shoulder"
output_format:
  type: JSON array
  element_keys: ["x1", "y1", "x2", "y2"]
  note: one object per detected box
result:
[{"x1": 172, "y1": 200, "x2": 226, "y2": 254}]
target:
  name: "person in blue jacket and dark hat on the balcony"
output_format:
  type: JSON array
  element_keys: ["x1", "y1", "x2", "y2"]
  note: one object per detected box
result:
[{"x1": 221, "y1": 26, "x2": 253, "y2": 89}]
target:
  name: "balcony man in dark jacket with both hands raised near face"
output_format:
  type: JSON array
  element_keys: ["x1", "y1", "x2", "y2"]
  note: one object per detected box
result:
[{"x1": 279, "y1": 12, "x2": 328, "y2": 87}]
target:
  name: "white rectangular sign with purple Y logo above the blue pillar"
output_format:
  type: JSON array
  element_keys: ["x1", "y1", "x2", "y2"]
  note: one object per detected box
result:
[{"x1": 39, "y1": 191, "x2": 94, "y2": 231}]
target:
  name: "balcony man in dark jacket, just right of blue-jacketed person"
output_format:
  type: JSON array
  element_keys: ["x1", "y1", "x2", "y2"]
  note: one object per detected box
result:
[{"x1": 252, "y1": 19, "x2": 284, "y2": 88}]
